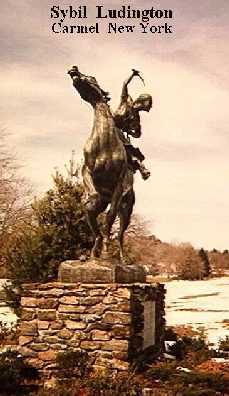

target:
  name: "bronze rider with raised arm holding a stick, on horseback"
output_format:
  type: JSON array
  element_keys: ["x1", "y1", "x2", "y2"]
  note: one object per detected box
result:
[{"x1": 114, "y1": 70, "x2": 152, "y2": 180}]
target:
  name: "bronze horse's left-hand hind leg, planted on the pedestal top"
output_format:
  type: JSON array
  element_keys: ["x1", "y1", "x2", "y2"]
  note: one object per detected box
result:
[{"x1": 86, "y1": 194, "x2": 107, "y2": 257}]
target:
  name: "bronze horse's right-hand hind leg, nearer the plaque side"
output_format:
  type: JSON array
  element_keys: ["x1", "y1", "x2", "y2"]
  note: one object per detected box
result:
[{"x1": 118, "y1": 190, "x2": 135, "y2": 262}]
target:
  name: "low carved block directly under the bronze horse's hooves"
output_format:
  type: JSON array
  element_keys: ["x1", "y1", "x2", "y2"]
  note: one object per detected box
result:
[{"x1": 58, "y1": 259, "x2": 146, "y2": 284}]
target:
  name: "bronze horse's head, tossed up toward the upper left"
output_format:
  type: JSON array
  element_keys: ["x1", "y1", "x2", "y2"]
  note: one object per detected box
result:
[{"x1": 68, "y1": 66, "x2": 110, "y2": 106}]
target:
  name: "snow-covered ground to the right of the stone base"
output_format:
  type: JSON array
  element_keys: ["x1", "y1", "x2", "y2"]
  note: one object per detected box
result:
[{"x1": 165, "y1": 277, "x2": 229, "y2": 344}]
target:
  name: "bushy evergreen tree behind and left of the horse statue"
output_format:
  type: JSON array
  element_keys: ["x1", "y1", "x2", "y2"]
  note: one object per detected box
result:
[{"x1": 7, "y1": 166, "x2": 92, "y2": 283}]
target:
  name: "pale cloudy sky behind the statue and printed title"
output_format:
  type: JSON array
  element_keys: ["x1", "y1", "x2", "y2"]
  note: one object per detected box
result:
[{"x1": 0, "y1": 0, "x2": 229, "y2": 250}]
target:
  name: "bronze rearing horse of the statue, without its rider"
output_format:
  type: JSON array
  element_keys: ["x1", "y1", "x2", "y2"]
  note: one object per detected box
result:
[{"x1": 68, "y1": 66, "x2": 135, "y2": 259}]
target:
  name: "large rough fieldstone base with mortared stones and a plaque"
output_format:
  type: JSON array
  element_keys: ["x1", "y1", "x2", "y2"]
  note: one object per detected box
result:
[{"x1": 19, "y1": 283, "x2": 165, "y2": 370}]
